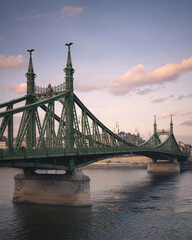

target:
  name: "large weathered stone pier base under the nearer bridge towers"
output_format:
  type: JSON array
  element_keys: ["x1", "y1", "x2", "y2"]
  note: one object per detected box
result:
[{"x1": 13, "y1": 169, "x2": 91, "y2": 206}]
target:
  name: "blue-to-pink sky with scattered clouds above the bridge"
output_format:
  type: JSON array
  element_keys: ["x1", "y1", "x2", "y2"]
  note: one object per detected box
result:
[{"x1": 0, "y1": 0, "x2": 192, "y2": 144}]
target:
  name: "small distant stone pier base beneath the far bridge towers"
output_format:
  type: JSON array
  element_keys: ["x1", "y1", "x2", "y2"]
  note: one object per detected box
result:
[{"x1": 147, "y1": 162, "x2": 180, "y2": 173}]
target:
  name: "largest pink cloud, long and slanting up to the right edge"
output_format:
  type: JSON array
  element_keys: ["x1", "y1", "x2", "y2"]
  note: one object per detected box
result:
[{"x1": 109, "y1": 57, "x2": 192, "y2": 95}]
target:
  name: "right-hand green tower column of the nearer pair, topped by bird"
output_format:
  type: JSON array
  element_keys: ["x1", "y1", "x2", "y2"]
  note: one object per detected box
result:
[{"x1": 64, "y1": 43, "x2": 74, "y2": 149}]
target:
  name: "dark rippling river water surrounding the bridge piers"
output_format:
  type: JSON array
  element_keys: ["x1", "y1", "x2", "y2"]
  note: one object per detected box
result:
[{"x1": 0, "y1": 168, "x2": 192, "y2": 240}]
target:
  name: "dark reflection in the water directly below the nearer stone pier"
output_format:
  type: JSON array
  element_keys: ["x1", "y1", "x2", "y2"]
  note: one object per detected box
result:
[{"x1": 14, "y1": 204, "x2": 92, "y2": 240}]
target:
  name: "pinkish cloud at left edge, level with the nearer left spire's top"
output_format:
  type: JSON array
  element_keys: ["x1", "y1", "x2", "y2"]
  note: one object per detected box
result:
[{"x1": 0, "y1": 55, "x2": 27, "y2": 71}]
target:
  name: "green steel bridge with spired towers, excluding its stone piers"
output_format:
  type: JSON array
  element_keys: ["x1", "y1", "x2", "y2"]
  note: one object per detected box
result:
[{"x1": 0, "y1": 43, "x2": 188, "y2": 171}]
